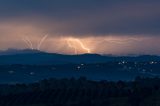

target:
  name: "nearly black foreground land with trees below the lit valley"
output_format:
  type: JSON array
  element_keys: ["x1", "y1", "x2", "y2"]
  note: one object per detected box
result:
[{"x1": 0, "y1": 77, "x2": 160, "y2": 106}]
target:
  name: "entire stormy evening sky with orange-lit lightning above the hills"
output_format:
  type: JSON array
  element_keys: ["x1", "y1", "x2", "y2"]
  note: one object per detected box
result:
[{"x1": 0, "y1": 0, "x2": 160, "y2": 55}]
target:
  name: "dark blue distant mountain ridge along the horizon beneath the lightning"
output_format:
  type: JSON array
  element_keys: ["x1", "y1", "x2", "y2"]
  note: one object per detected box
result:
[{"x1": 0, "y1": 49, "x2": 160, "y2": 65}]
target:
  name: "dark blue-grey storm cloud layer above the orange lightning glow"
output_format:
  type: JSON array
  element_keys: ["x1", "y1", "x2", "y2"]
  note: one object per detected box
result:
[{"x1": 0, "y1": 0, "x2": 160, "y2": 36}]
